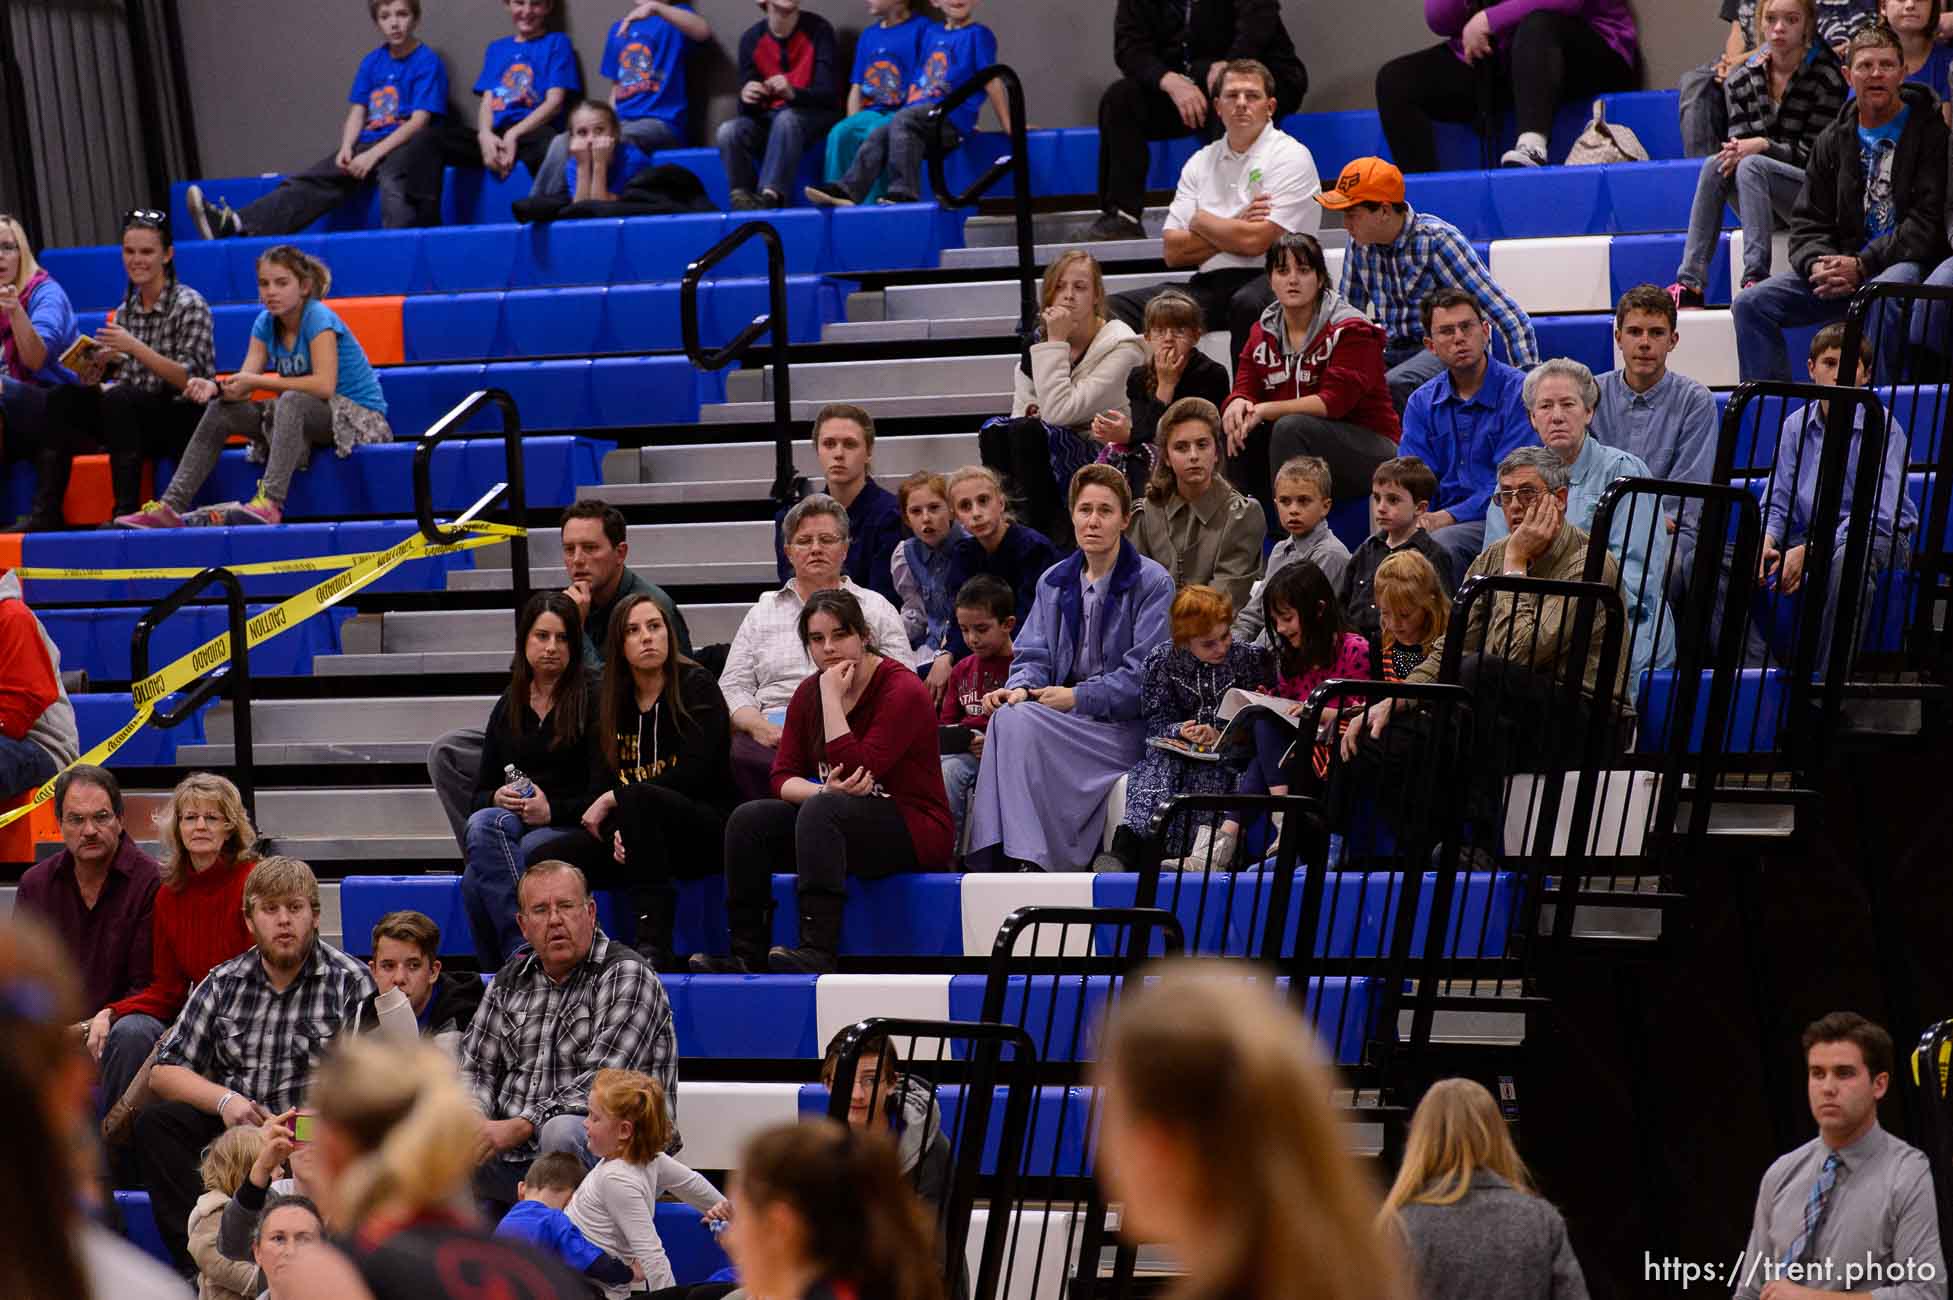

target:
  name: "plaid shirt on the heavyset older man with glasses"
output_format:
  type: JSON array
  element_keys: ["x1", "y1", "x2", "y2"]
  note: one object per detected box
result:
[{"x1": 461, "y1": 929, "x2": 680, "y2": 1159}]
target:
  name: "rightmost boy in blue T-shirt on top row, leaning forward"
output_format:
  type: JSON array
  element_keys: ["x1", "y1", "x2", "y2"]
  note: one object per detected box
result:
[{"x1": 807, "y1": 0, "x2": 1010, "y2": 207}]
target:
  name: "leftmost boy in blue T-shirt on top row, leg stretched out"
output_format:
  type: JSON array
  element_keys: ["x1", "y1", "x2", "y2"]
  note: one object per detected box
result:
[{"x1": 186, "y1": 0, "x2": 447, "y2": 240}]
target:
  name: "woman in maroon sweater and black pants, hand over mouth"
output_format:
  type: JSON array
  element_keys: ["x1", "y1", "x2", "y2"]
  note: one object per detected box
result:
[{"x1": 691, "y1": 588, "x2": 953, "y2": 974}]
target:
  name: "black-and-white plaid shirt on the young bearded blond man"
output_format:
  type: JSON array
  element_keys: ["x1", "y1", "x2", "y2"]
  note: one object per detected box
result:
[{"x1": 156, "y1": 941, "x2": 373, "y2": 1115}]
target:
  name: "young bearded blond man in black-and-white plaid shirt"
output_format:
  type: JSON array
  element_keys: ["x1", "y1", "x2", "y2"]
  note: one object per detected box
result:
[{"x1": 135, "y1": 857, "x2": 373, "y2": 1277}]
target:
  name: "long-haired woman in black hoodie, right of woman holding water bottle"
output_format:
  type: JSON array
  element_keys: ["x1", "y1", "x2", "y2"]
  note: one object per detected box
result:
[{"x1": 582, "y1": 595, "x2": 734, "y2": 970}]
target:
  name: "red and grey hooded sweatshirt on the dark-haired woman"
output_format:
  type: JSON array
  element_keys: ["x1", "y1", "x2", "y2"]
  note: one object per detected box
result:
[{"x1": 1226, "y1": 289, "x2": 1404, "y2": 443}]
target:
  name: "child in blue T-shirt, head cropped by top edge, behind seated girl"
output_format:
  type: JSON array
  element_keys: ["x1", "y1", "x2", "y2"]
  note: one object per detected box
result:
[{"x1": 529, "y1": 0, "x2": 713, "y2": 199}]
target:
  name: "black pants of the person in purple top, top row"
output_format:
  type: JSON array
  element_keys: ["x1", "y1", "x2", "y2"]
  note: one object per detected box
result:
[{"x1": 1377, "y1": 12, "x2": 1635, "y2": 172}]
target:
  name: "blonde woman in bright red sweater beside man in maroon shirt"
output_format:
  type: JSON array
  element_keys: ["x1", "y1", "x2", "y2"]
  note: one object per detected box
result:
[{"x1": 88, "y1": 771, "x2": 258, "y2": 1113}]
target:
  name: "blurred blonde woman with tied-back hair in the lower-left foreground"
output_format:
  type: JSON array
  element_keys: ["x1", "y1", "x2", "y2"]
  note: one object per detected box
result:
[{"x1": 279, "y1": 1036, "x2": 590, "y2": 1300}]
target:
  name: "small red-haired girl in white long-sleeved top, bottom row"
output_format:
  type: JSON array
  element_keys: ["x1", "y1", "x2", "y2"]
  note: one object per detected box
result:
[{"x1": 566, "y1": 1070, "x2": 732, "y2": 1300}]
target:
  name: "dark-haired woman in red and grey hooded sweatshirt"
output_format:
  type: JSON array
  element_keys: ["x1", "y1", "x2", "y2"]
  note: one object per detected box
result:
[{"x1": 1221, "y1": 234, "x2": 1402, "y2": 506}]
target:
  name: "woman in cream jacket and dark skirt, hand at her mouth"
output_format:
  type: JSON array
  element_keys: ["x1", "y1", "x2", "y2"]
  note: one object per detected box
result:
[{"x1": 977, "y1": 252, "x2": 1146, "y2": 550}]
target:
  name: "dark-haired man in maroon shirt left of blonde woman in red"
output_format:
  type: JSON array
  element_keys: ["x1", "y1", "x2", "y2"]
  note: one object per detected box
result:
[{"x1": 14, "y1": 765, "x2": 160, "y2": 1029}]
